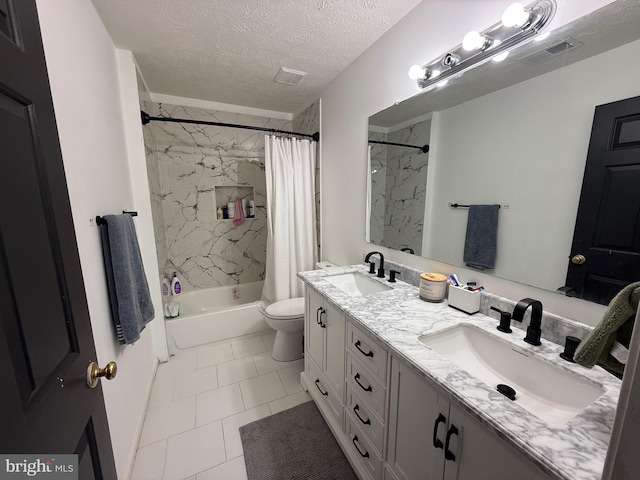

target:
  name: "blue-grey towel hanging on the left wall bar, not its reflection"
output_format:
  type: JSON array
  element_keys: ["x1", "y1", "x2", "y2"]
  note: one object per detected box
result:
[{"x1": 100, "y1": 214, "x2": 155, "y2": 345}]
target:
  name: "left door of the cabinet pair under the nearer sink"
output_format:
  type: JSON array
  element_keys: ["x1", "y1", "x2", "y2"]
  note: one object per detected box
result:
[{"x1": 387, "y1": 358, "x2": 449, "y2": 480}]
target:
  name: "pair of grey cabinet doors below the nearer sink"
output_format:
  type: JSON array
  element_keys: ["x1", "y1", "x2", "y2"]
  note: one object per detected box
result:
[{"x1": 385, "y1": 358, "x2": 548, "y2": 480}]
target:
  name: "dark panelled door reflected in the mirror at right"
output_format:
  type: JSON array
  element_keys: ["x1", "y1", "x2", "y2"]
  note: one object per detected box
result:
[{"x1": 567, "y1": 97, "x2": 640, "y2": 304}]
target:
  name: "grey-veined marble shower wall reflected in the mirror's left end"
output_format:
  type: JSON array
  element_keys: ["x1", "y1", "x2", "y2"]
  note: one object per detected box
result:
[{"x1": 369, "y1": 120, "x2": 431, "y2": 255}]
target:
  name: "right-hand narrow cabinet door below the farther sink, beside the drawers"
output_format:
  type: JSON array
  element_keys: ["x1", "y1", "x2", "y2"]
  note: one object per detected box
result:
[{"x1": 323, "y1": 302, "x2": 346, "y2": 398}]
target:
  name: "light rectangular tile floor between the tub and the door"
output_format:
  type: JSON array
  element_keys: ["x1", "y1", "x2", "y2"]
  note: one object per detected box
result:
[{"x1": 131, "y1": 332, "x2": 311, "y2": 480}]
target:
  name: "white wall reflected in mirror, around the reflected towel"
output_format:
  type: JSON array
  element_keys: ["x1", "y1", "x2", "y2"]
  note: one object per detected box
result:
[{"x1": 424, "y1": 41, "x2": 640, "y2": 290}]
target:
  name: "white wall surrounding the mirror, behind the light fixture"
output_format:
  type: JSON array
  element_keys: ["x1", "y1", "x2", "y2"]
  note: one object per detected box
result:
[{"x1": 321, "y1": 0, "x2": 611, "y2": 324}]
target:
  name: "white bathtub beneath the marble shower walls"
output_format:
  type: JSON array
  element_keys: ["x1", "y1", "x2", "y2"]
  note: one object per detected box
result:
[{"x1": 165, "y1": 282, "x2": 273, "y2": 354}]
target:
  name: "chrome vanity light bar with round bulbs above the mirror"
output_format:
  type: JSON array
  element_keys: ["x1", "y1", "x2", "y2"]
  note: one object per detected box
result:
[{"x1": 409, "y1": 0, "x2": 556, "y2": 89}]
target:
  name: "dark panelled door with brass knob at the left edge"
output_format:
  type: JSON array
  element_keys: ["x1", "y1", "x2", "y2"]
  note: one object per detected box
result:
[{"x1": 0, "y1": 0, "x2": 116, "y2": 480}]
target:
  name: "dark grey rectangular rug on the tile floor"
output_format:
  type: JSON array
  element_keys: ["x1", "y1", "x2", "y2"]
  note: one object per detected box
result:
[{"x1": 240, "y1": 401, "x2": 358, "y2": 480}]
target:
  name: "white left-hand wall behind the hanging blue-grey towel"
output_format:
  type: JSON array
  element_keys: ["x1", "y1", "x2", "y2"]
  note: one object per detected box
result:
[{"x1": 36, "y1": 0, "x2": 162, "y2": 479}]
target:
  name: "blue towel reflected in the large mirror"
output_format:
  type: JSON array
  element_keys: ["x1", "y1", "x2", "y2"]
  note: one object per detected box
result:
[{"x1": 463, "y1": 205, "x2": 500, "y2": 270}]
